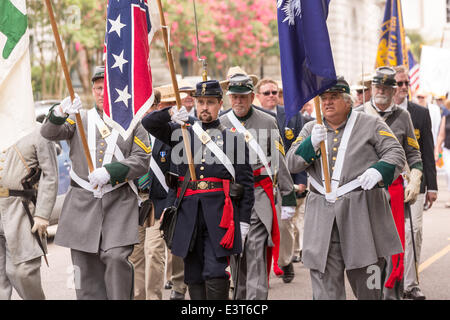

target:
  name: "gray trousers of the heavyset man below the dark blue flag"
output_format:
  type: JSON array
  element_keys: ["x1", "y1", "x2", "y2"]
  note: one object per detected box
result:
[{"x1": 310, "y1": 223, "x2": 386, "y2": 300}]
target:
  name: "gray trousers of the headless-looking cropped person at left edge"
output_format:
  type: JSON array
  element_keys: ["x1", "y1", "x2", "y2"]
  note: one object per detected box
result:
[{"x1": 0, "y1": 215, "x2": 45, "y2": 300}]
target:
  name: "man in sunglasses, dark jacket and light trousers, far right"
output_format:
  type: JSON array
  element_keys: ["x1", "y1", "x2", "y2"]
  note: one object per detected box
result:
[{"x1": 394, "y1": 66, "x2": 438, "y2": 300}]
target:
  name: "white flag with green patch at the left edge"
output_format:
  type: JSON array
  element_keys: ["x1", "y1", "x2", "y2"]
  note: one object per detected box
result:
[{"x1": 0, "y1": 0, "x2": 36, "y2": 151}]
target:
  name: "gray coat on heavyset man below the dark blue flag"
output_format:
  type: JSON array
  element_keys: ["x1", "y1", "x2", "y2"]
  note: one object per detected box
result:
[{"x1": 287, "y1": 111, "x2": 405, "y2": 272}]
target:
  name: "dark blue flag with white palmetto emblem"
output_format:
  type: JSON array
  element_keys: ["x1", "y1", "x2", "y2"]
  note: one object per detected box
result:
[{"x1": 277, "y1": 0, "x2": 336, "y2": 123}]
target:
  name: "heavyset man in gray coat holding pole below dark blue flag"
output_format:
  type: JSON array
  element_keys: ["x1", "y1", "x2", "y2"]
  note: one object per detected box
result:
[{"x1": 287, "y1": 78, "x2": 405, "y2": 300}]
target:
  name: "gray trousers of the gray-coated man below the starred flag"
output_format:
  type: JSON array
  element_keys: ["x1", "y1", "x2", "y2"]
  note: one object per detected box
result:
[{"x1": 70, "y1": 246, "x2": 134, "y2": 300}]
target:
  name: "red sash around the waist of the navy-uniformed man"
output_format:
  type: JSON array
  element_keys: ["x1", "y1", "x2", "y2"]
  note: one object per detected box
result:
[{"x1": 177, "y1": 177, "x2": 235, "y2": 249}]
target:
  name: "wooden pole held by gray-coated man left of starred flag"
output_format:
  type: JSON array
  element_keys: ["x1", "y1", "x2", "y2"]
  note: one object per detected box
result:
[{"x1": 45, "y1": 0, "x2": 94, "y2": 172}]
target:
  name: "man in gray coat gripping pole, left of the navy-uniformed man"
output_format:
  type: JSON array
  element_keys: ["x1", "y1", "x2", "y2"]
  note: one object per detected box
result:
[{"x1": 41, "y1": 67, "x2": 150, "y2": 300}]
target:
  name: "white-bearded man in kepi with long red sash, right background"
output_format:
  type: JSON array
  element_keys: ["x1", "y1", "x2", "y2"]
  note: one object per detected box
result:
[{"x1": 355, "y1": 67, "x2": 423, "y2": 299}]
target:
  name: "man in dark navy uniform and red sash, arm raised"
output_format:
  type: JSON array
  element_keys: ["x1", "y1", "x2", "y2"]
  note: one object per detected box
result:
[{"x1": 142, "y1": 80, "x2": 254, "y2": 300}]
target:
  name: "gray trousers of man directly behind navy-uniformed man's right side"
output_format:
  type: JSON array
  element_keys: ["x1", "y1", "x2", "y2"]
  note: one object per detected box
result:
[{"x1": 231, "y1": 210, "x2": 269, "y2": 300}]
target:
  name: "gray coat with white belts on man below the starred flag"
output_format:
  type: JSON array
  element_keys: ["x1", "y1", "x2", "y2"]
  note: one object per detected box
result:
[{"x1": 41, "y1": 111, "x2": 151, "y2": 253}]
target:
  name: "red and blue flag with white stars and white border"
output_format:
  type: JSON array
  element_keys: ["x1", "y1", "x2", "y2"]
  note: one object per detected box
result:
[{"x1": 103, "y1": 0, "x2": 155, "y2": 139}]
